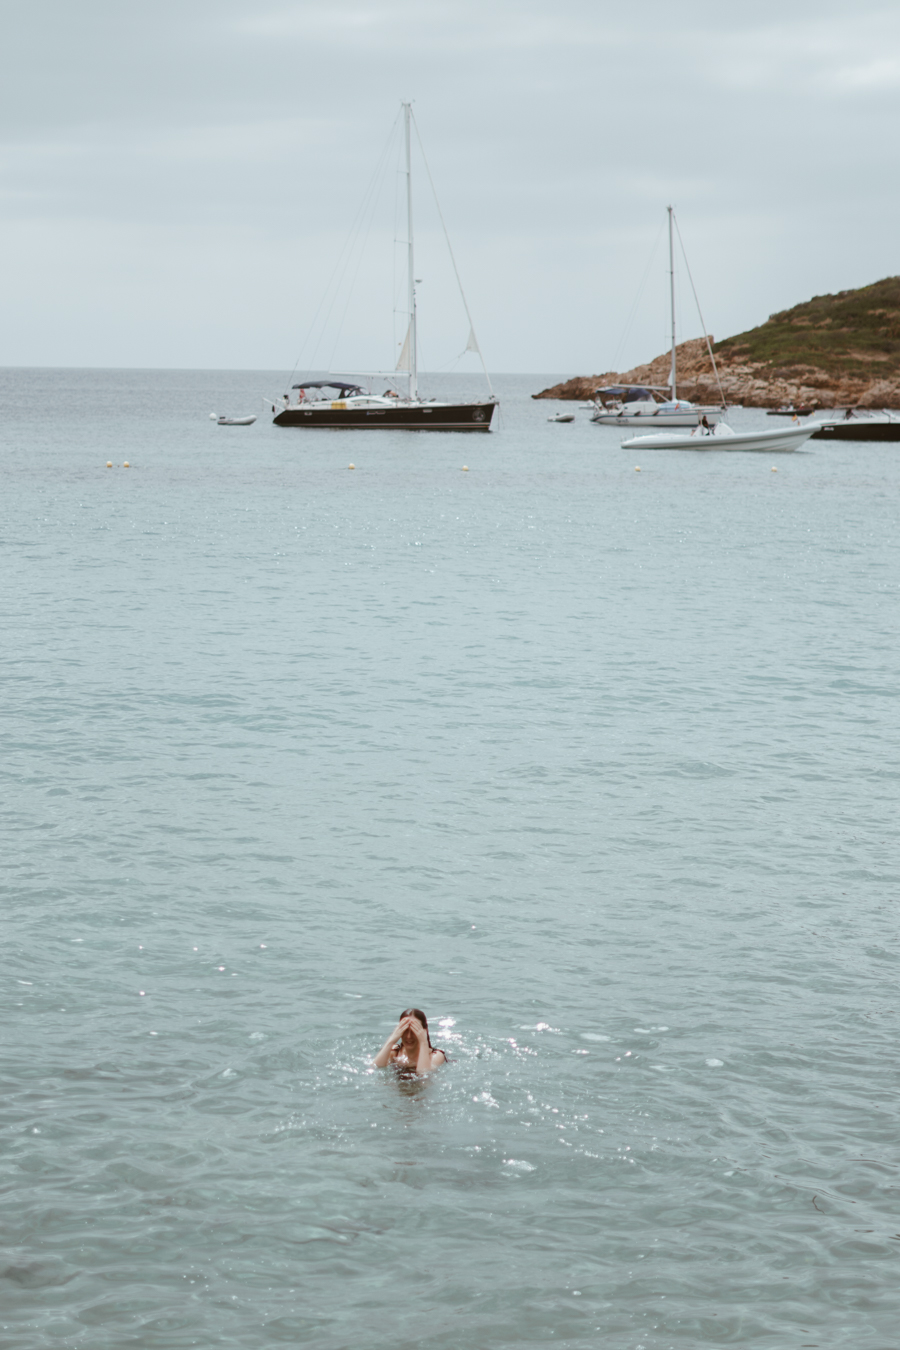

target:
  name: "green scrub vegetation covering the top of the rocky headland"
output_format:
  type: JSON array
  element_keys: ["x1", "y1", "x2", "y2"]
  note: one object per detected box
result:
[{"x1": 715, "y1": 277, "x2": 900, "y2": 379}]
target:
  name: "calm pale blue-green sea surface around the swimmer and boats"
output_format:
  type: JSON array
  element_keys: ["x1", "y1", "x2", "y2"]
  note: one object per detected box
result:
[{"x1": 0, "y1": 371, "x2": 900, "y2": 1350}]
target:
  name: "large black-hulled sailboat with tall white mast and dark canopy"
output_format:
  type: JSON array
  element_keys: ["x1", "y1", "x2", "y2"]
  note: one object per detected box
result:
[{"x1": 273, "y1": 103, "x2": 497, "y2": 431}]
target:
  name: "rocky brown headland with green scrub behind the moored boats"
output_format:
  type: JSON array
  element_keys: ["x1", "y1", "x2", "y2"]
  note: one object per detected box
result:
[{"x1": 532, "y1": 277, "x2": 900, "y2": 408}]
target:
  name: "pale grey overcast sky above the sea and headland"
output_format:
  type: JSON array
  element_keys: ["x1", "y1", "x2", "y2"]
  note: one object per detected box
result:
[{"x1": 0, "y1": 0, "x2": 900, "y2": 375}]
